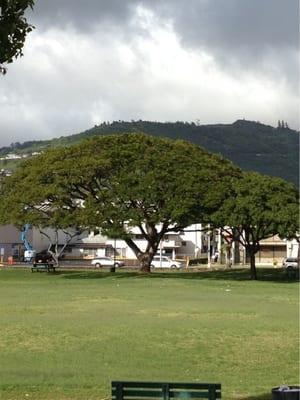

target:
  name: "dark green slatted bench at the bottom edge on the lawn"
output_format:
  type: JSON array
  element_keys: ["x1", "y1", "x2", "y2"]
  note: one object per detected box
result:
[{"x1": 111, "y1": 381, "x2": 221, "y2": 400}]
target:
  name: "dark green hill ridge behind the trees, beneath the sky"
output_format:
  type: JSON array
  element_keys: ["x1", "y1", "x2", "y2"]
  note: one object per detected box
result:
[{"x1": 0, "y1": 120, "x2": 299, "y2": 185}]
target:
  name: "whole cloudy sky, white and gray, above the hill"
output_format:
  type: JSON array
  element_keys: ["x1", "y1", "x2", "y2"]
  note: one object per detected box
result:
[{"x1": 0, "y1": 0, "x2": 299, "y2": 146}]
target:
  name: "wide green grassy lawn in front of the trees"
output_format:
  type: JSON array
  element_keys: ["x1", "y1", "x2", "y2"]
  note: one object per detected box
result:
[{"x1": 0, "y1": 269, "x2": 299, "y2": 400}]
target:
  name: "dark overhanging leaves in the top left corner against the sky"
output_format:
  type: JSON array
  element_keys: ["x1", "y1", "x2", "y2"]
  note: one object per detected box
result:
[{"x1": 0, "y1": 0, "x2": 34, "y2": 73}]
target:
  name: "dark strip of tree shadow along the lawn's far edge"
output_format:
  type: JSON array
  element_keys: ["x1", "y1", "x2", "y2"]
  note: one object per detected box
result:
[{"x1": 60, "y1": 268, "x2": 297, "y2": 284}]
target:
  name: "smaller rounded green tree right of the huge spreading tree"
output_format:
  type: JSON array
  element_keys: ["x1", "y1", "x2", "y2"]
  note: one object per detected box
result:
[{"x1": 213, "y1": 172, "x2": 299, "y2": 279}]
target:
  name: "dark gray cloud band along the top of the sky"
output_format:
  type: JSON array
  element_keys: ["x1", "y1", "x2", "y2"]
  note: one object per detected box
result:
[{"x1": 29, "y1": 0, "x2": 299, "y2": 87}]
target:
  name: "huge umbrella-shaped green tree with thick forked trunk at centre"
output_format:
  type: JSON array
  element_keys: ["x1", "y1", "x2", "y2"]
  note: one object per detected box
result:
[{"x1": 0, "y1": 133, "x2": 240, "y2": 271}]
